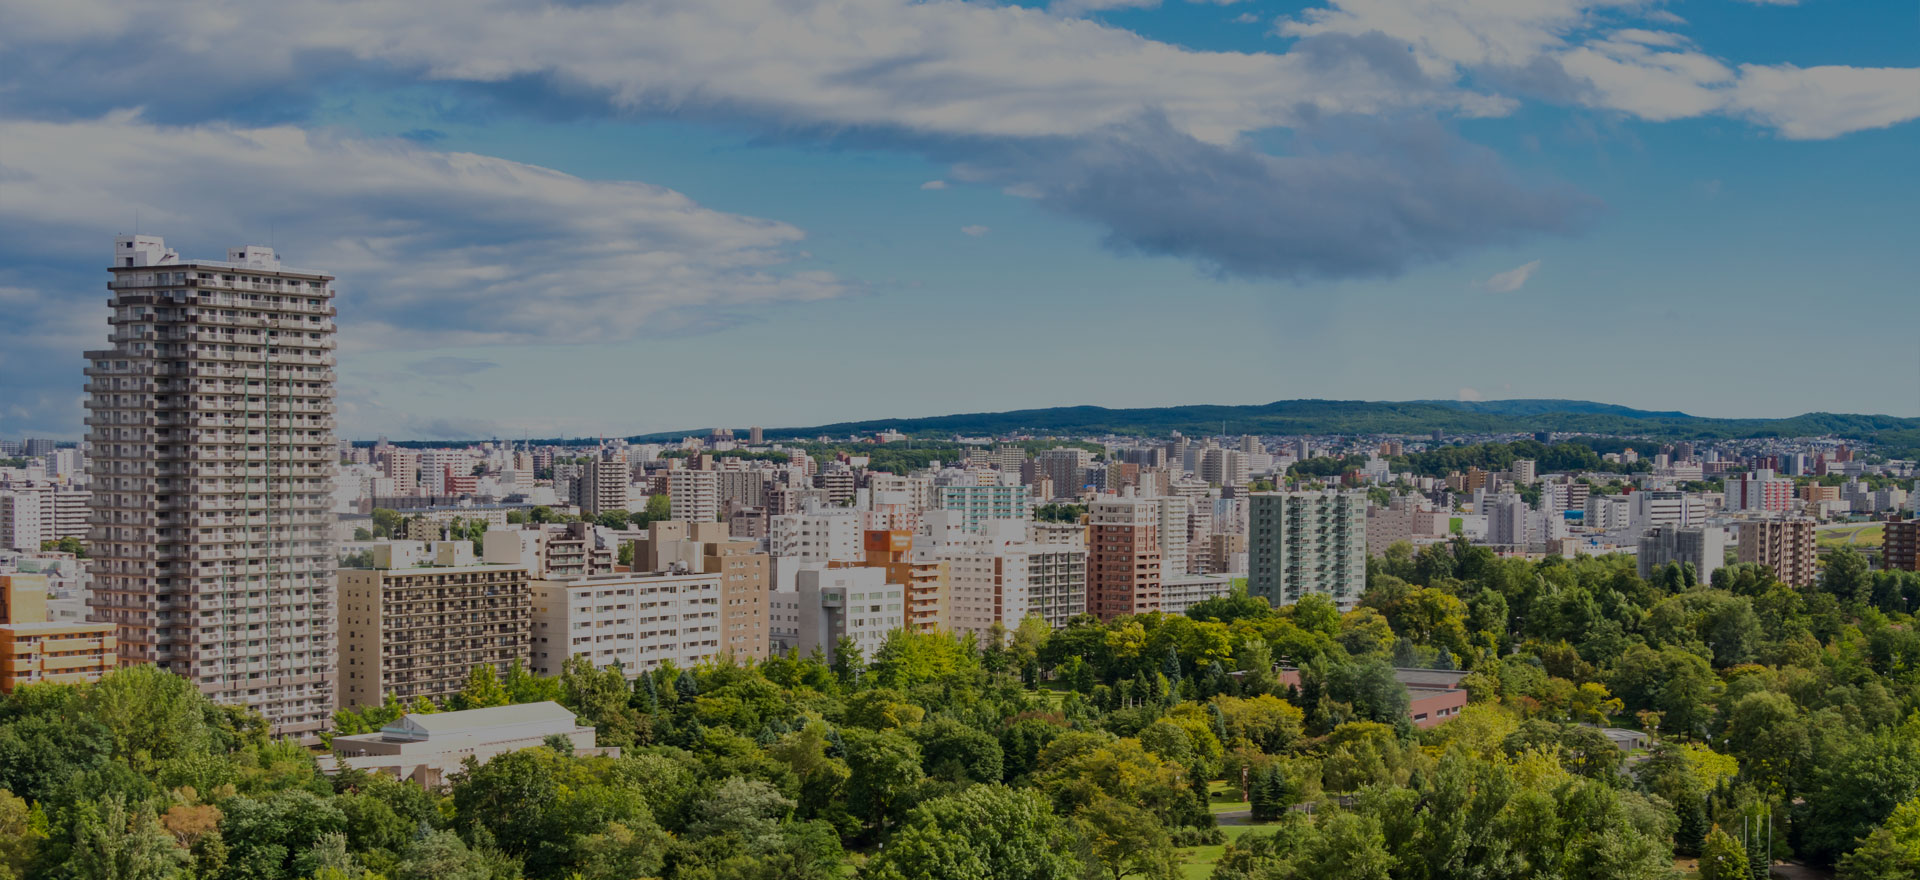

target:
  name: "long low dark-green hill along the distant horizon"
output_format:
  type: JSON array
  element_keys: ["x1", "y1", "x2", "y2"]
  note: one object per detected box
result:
[{"x1": 630, "y1": 400, "x2": 1920, "y2": 450}]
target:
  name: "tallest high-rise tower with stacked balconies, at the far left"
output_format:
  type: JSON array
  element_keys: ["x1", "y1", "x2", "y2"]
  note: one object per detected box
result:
[{"x1": 86, "y1": 234, "x2": 338, "y2": 742}]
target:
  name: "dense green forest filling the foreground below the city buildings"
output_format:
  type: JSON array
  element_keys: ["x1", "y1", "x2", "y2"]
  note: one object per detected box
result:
[{"x1": 0, "y1": 544, "x2": 1920, "y2": 880}]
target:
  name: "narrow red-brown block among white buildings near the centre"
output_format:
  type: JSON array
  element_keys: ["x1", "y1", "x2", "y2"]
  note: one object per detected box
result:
[{"x1": 1087, "y1": 494, "x2": 1162, "y2": 621}]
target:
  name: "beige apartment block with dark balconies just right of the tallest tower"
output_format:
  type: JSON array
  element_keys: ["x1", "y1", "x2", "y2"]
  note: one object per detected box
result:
[{"x1": 340, "y1": 542, "x2": 532, "y2": 707}]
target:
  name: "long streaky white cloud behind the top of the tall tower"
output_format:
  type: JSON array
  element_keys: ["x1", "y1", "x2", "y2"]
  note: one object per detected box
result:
[{"x1": 0, "y1": 115, "x2": 847, "y2": 348}]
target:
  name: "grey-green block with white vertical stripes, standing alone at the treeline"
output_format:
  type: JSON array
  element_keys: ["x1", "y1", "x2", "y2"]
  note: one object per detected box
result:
[{"x1": 1246, "y1": 490, "x2": 1367, "y2": 611}]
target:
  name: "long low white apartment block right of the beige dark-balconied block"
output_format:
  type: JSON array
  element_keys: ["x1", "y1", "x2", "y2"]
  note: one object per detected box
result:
[{"x1": 528, "y1": 573, "x2": 726, "y2": 680}]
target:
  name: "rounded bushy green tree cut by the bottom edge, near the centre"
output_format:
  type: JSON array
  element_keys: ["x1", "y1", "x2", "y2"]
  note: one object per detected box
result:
[{"x1": 860, "y1": 786, "x2": 1081, "y2": 880}]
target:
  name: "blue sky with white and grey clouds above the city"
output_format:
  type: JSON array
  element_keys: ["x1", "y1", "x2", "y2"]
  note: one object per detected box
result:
[{"x1": 0, "y1": 0, "x2": 1920, "y2": 440}]
